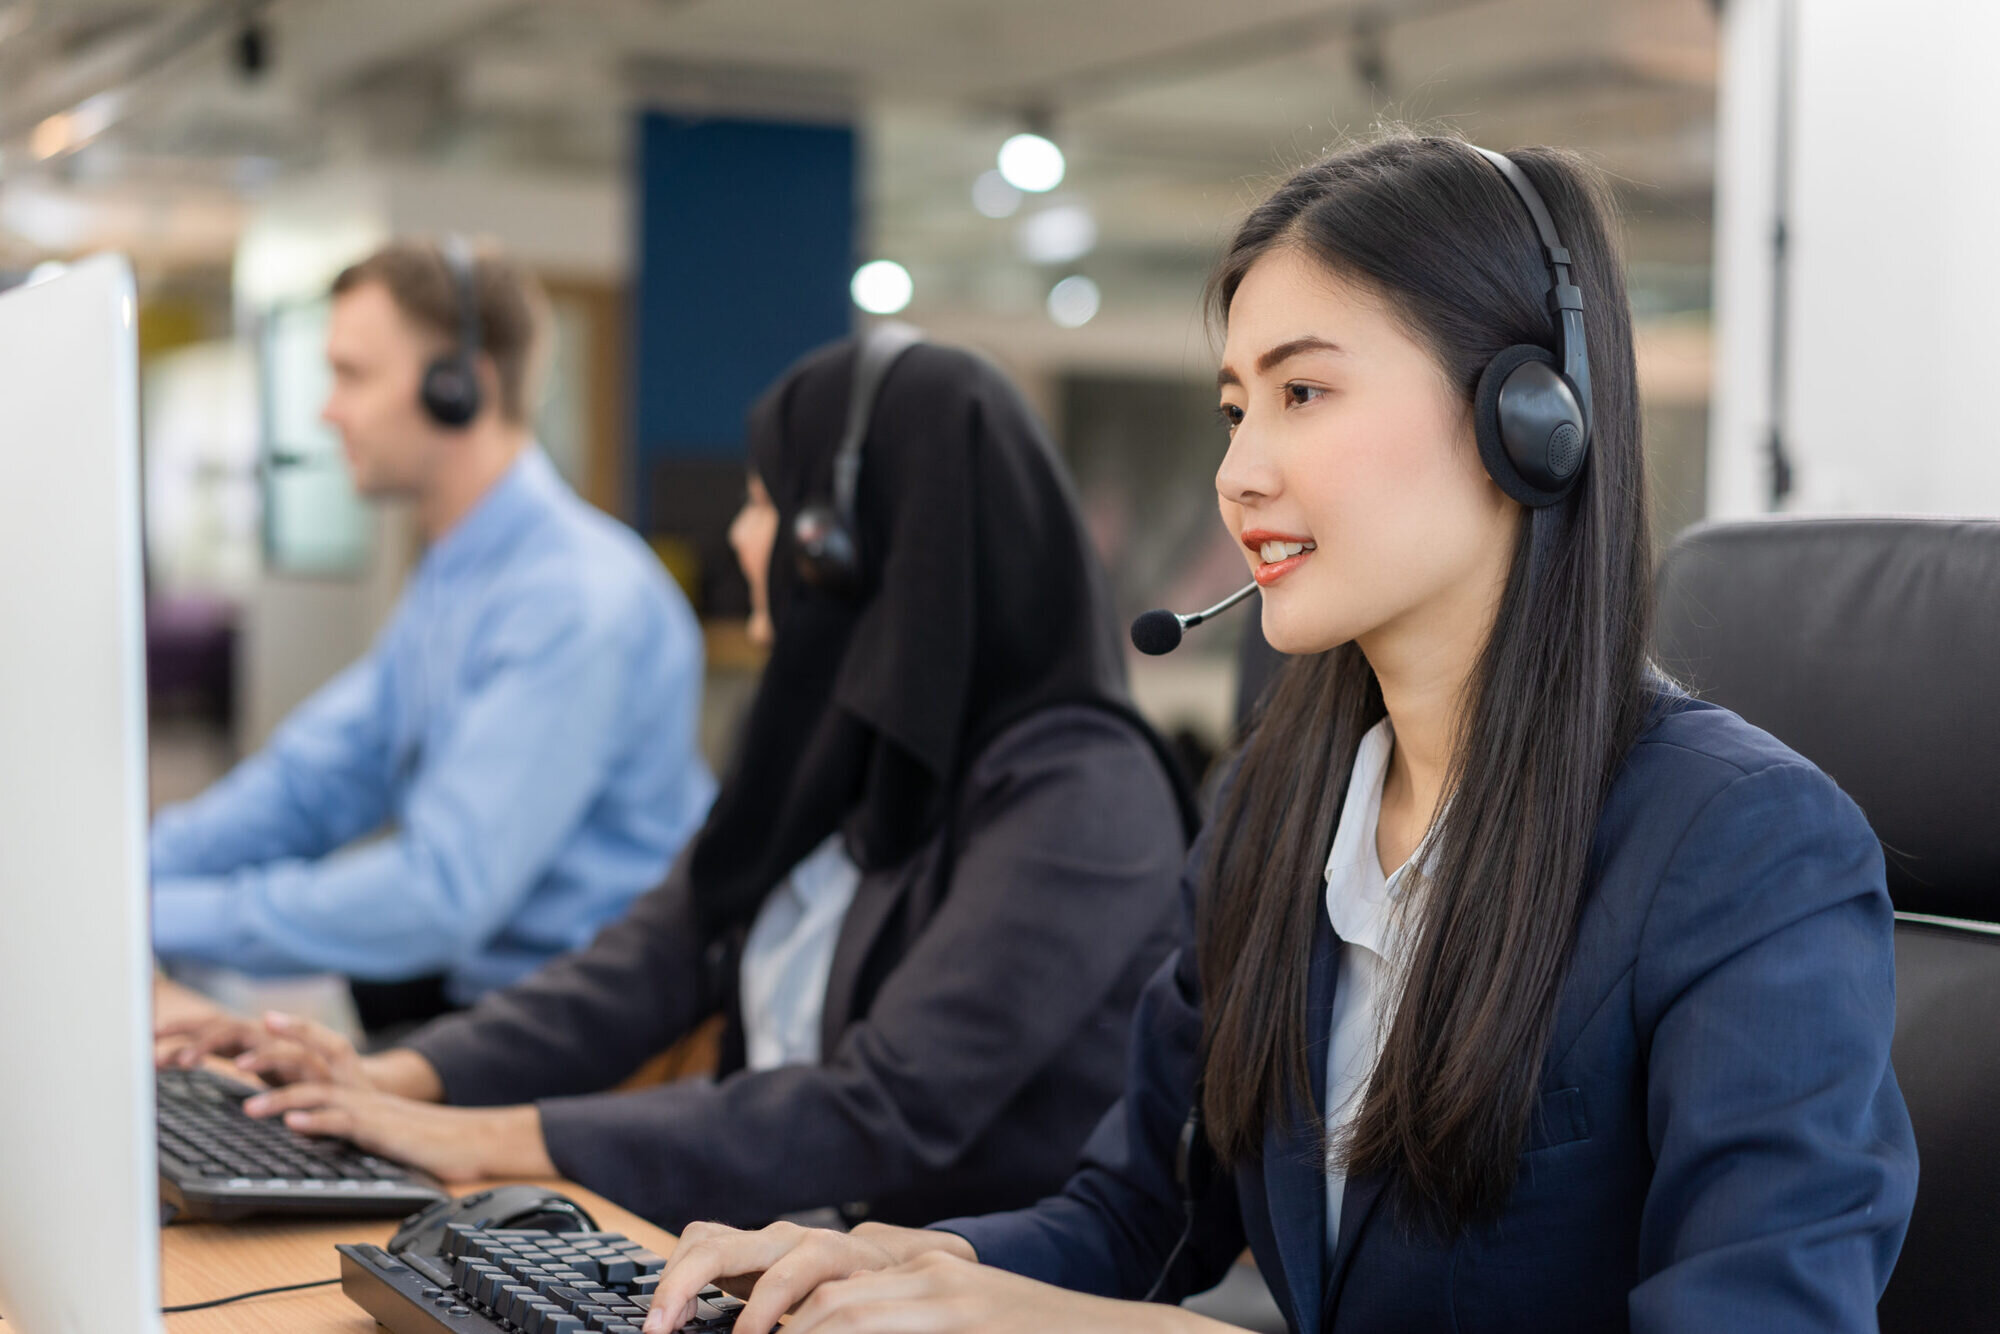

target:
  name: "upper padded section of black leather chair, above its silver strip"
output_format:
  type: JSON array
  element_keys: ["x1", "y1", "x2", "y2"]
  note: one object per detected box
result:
[{"x1": 1658, "y1": 518, "x2": 2000, "y2": 920}]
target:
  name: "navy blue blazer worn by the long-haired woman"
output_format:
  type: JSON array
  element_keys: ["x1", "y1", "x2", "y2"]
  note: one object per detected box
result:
[{"x1": 938, "y1": 696, "x2": 1916, "y2": 1334}]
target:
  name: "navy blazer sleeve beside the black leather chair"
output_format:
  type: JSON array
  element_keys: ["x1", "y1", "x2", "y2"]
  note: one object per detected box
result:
[{"x1": 1630, "y1": 764, "x2": 1916, "y2": 1334}]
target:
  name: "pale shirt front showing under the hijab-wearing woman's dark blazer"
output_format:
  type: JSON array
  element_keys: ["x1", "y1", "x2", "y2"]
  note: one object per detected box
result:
[{"x1": 738, "y1": 830, "x2": 862, "y2": 1070}]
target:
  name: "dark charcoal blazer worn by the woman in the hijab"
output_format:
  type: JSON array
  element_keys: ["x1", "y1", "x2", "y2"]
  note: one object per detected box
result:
[{"x1": 410, "y1": 706, "x2": 1186, "y2": 1228}]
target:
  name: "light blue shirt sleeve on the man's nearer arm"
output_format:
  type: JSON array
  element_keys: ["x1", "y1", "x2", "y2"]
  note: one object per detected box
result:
[{"x1": 154, "y1": 590, "x2": 626, "y2": 980}]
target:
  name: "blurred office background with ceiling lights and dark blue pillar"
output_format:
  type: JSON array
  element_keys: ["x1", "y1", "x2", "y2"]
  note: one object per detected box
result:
[{"x1": 0, "y1": 0, "x2": 2000, "y2": 800}]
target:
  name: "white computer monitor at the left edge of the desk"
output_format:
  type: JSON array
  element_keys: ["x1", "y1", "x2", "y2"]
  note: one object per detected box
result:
[{"x1": 0, "y1": 256, "x2": 162, "y2": 1334}]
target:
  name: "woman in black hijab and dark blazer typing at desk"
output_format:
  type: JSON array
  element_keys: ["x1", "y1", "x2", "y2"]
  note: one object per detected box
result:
[{"x1": 164, "y1": 332, "x2": 1188, "y2": 1228}]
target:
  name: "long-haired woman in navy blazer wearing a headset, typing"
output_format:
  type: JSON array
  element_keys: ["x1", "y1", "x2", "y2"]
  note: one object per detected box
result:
[{"x1": 648, "y1": 136, "x2": 1916, "y2": 1334}]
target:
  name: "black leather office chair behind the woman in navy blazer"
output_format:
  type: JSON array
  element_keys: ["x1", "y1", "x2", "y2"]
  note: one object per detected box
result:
[{"x1": 1658, "y1": 518, "x2": 2000, "y2": 1334}]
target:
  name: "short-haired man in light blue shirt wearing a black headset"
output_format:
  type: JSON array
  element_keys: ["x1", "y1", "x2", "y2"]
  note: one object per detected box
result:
[{"x1": 152, "y1": 242, "x2": 714, "y2": 1028}]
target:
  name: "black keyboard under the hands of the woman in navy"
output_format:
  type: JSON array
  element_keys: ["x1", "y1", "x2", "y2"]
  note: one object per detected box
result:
[{"x1": 334, "y1": 1224, "x2": 742, "y2": 1334}]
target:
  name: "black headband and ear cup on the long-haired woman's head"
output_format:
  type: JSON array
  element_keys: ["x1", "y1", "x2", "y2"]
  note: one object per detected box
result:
[{"x1": 1472, "y1": 146, "x2": 1590, "y2": 510}]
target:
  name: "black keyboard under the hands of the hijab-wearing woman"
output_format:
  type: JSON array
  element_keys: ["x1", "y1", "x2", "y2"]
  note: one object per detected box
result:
[{"x1": 156, "y1": 1070, "x2": 444, "y2": 1220}]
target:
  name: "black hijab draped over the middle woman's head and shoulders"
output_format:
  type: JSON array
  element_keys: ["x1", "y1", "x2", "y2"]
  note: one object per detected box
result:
[{"x1": 688, "y1": 340, "x2": 1132, "y2": 932}]
